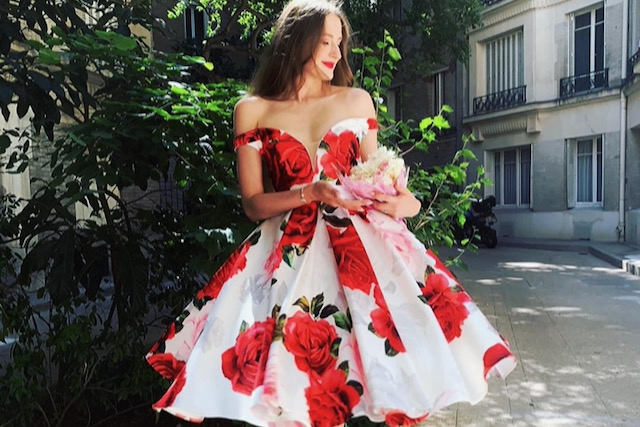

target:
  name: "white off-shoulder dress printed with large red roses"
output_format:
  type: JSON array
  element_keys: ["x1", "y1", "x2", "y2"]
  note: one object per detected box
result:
[{"x1": 147, "y1": 118, "x2": 515, "y2": 427}]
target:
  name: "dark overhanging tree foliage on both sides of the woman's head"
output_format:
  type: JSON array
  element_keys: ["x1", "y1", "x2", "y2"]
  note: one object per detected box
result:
[{"x1": 169, "y1": 0, "x2": 484, "y2": 78}]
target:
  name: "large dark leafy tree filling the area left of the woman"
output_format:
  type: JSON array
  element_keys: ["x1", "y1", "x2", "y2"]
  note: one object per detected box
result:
[{"x1": 0, "y1": 0, "x2": 250, "y2": 425}]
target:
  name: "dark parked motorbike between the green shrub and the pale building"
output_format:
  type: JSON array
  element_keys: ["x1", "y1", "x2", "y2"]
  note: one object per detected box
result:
[{"x1": 453, "y1": 196, "x2": 498, "y2": 249}]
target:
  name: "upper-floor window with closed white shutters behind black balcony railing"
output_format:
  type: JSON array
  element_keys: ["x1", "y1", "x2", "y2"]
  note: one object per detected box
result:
[{"x1": 485, "y1": 30, "x2": 524, "y2": 93}]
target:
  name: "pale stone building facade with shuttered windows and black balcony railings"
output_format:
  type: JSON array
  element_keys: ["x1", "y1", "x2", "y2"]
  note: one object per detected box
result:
[{"x1": 462, "y1": 0, "x2": 640, "y2": 244}]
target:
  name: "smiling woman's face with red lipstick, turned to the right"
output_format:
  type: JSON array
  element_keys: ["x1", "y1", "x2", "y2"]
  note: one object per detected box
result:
[{"x1": 303, "y1": 14, "x2": 342, "y2": 81}]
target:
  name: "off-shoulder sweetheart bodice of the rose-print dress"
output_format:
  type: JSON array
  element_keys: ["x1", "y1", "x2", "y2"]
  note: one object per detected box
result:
[{"x1": 233, "y1": 118, "x2": 378, "y2": 191}]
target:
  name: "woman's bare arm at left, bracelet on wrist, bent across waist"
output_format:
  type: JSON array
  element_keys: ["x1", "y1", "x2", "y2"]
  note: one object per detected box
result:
[{"x1": 234, "y1": 97, "x2": 370, "y2": 221}]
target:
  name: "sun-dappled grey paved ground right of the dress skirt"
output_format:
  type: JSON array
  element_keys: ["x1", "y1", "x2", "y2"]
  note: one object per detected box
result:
[{"x1": 422, "y1": 239, "x2": 640, "y2": 427}]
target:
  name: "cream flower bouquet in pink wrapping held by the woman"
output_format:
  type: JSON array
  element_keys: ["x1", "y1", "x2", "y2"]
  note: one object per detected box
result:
[{"x1": 340, "y1": 146, "x2": 409, "y2": 199}]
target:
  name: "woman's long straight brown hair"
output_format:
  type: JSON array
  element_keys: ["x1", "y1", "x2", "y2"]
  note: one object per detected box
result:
[{"x1": 252, "y1": 0, "x2": 353, "y2": 99}]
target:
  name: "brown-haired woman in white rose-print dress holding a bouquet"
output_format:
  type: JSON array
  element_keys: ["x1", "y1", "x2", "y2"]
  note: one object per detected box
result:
[{"x1": 148, "y1": 0, "x2": 515, "y2": 427}]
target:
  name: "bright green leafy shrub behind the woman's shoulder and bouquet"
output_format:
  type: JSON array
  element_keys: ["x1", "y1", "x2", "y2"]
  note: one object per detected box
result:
[{"x1": 354, "y1": 31, "x2": 490, "y2": 258}]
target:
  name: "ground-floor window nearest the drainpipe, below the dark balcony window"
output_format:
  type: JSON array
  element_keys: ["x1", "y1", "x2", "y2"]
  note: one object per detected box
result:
[{"x1": 567, "y1": 136, "x2": 603, "y2": 207}]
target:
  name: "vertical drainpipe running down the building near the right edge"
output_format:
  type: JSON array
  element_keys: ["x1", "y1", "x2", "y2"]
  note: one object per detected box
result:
[{"x1": 616, "y1": 0, "x2": 629, "y2": 242}]
